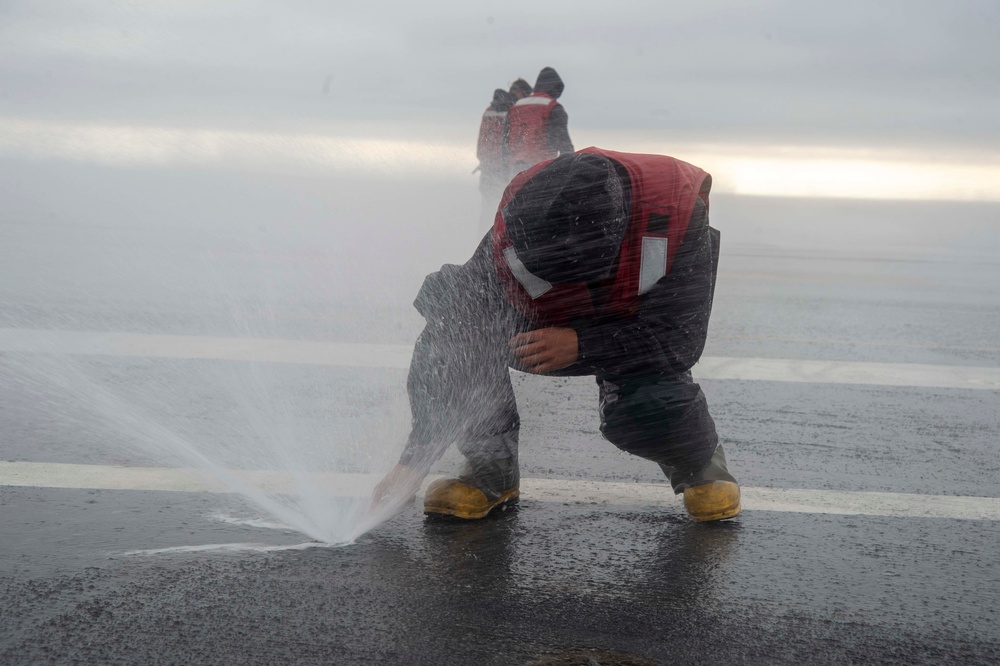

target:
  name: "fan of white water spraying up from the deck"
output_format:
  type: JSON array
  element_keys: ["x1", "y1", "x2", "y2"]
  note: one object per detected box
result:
[{"x1": 3, "y1": 330, "x2": 408, "y2": 544}]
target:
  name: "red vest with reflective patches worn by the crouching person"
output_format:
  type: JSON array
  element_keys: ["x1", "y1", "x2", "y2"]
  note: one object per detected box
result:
[{"x1": 493, "y1": 148, "x2": 711, "y2": 326}]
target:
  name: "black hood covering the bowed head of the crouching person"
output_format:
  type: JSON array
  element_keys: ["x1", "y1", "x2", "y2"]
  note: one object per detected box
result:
[{"x1": 503, "y1": 153, "x2": 628, "y2": 284}]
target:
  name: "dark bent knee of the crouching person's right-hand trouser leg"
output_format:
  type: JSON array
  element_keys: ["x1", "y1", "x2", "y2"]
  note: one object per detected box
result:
[{"x1": 601, "y1": 384, "x2": 719, "y2": 472}]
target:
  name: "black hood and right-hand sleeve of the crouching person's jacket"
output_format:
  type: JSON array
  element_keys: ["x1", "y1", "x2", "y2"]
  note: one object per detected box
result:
[{"x1": 504, "y1": 153, "x2": 719, "y2": 379}]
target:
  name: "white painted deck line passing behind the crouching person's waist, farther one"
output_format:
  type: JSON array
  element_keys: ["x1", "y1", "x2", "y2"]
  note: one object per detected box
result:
[{"x1": 0, "y1": 328, "x2": 1000, "y2": 390}]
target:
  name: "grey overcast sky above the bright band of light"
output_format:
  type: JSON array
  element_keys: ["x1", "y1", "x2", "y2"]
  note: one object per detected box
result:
[{"x1": 0, "y1": 0, "x2": 1000, "y2": 198}]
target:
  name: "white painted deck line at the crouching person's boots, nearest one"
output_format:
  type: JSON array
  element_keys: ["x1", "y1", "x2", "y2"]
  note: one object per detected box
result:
[{"x1": 0, "y1": 461, "x2": 1000, "y2": 521}]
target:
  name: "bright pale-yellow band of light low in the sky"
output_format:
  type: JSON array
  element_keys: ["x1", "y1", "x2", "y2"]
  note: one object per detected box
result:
[{"x1": 0, "y1": 117, "x2": 1000, "y2": 203}]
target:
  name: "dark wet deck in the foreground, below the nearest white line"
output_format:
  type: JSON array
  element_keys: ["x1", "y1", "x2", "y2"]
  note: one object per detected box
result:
[{"x1": 0, "y1": 489, "x2": 1000, "y2": 664}]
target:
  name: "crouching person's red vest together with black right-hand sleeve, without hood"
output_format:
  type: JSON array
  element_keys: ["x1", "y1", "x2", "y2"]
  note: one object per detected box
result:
[{"x1": 492, "y1": 148, "x2": 719, "y2": 379}]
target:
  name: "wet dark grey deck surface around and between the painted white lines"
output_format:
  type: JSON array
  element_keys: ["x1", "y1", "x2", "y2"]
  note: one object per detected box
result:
[{"x1": 0, "y1": 162, "x2": 1000, "y2": 664}]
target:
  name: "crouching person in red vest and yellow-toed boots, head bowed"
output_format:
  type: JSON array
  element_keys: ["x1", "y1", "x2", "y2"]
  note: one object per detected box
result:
[{"x1": 374, "y1": 148, "x2": 740, "y2": 521}]
